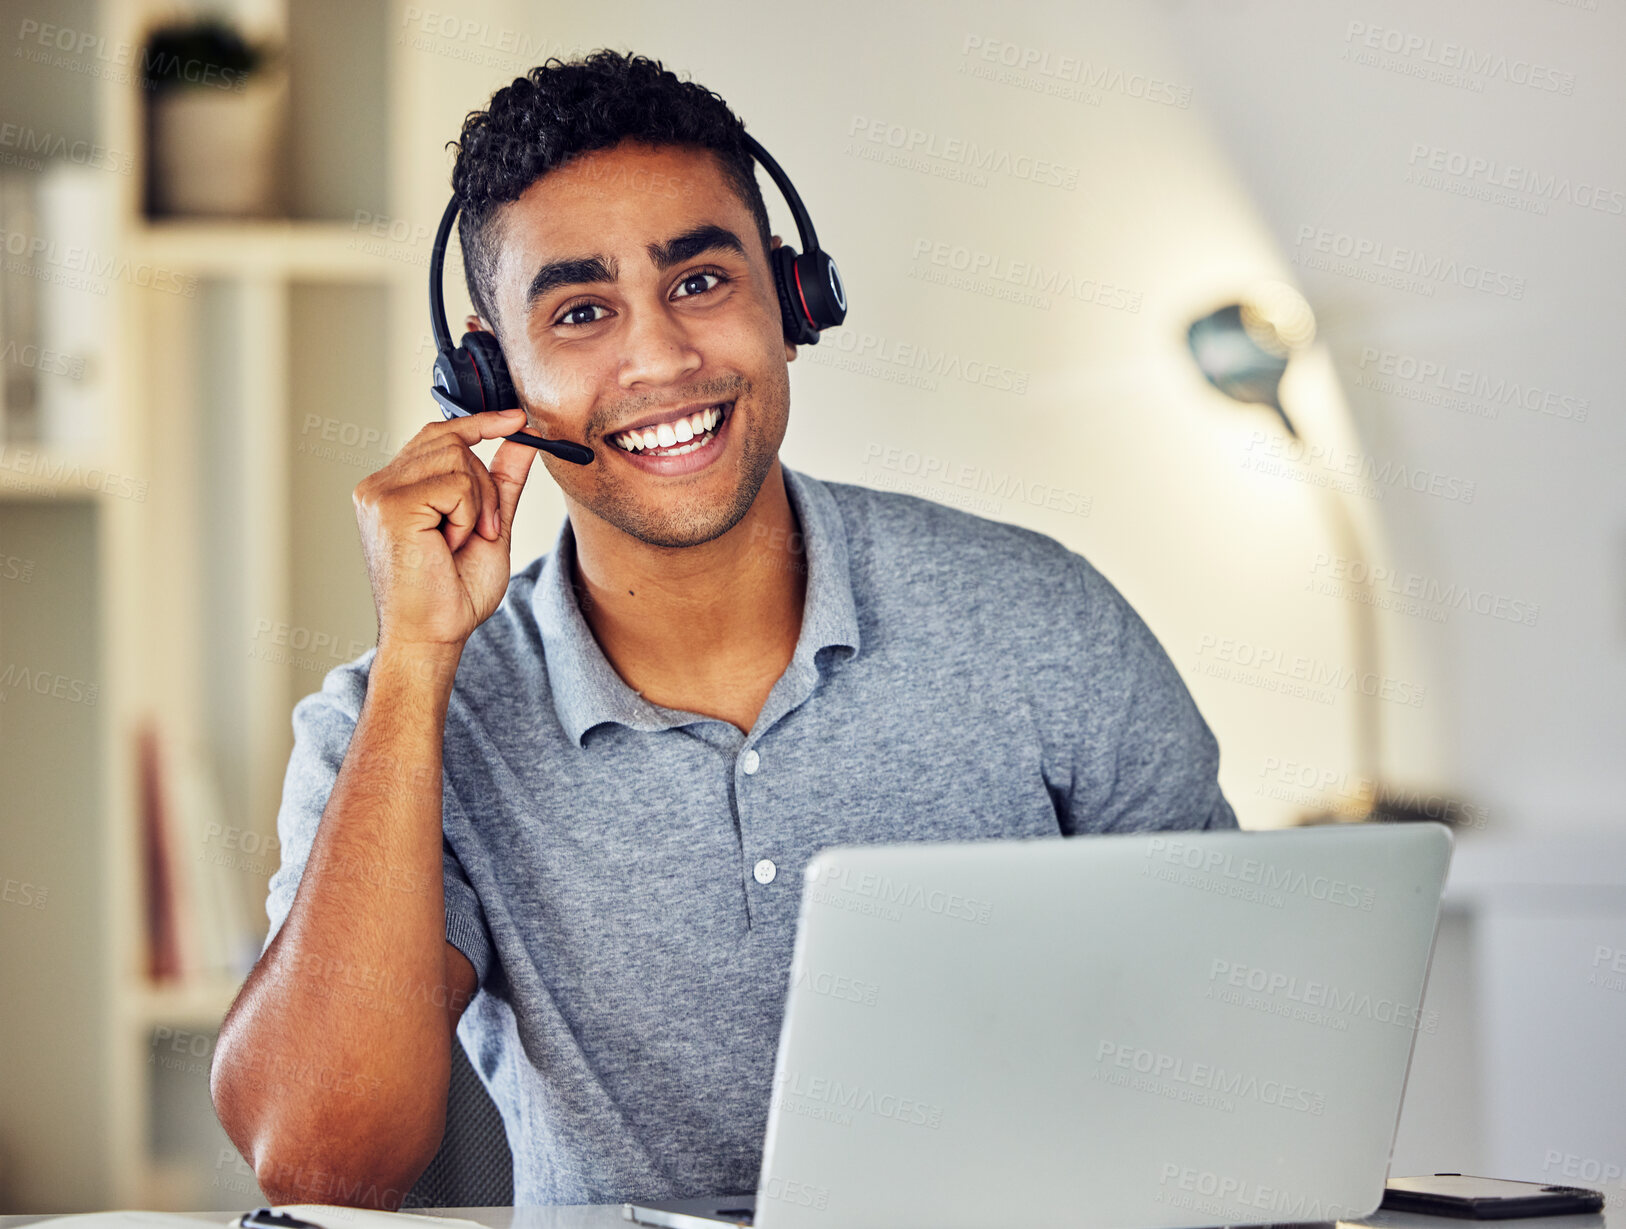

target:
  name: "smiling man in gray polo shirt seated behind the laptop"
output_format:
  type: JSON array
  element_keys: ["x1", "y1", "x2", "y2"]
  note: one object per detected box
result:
[{"x1": 213, "y1": 52, "x2": 1236, "y2": 1206}]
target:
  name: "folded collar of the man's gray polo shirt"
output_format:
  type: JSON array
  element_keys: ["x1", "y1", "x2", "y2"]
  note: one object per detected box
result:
[{"x1": 532, "y1": 462, "x2": 859, "y2": 746}]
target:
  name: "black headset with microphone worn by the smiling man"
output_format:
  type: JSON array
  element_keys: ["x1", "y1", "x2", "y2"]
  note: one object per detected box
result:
[{"x1": 429, "y1": 133, "x2": 847, "y2": 465}]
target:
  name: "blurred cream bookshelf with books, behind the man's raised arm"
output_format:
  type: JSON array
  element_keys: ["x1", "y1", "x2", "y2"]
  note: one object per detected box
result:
[{"x1": 0, "y1": 0, "x2": 428, "y2": 1213}]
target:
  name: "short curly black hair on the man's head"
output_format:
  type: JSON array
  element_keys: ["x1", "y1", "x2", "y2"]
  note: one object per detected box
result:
[{"x1": 447, "y1": 49, "x2": 771, "y2": 338}]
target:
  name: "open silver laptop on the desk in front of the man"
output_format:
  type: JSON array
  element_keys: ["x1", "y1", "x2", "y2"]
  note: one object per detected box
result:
[{"x1": 623, "y1": 823, "x2": 1452, "y2": 1229}]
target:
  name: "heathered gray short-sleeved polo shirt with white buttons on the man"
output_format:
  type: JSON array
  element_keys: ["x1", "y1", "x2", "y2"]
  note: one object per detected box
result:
[{"x1": 267, "y1": 467, "x2": 1236, "y2": 1205}]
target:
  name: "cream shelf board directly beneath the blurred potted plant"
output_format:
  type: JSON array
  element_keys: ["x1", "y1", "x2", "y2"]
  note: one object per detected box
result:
[{"x1": 127, "y1": 216, "x2": 429, "y2": 283}]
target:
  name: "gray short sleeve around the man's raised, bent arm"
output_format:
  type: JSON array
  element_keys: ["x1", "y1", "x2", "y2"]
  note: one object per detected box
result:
[{"x1": 260, "y1": 650, "x2": 491, "y2": 984}]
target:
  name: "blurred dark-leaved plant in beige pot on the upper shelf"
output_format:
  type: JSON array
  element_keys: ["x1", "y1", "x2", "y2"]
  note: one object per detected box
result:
[{"x1": 138, "y1": 16, "x2": 288, "y2": 216}]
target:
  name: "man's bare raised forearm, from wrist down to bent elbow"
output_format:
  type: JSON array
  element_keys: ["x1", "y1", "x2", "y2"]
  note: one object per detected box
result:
[{"x1": 213, "y1": 649, "x2": 462, "y2": 1203}]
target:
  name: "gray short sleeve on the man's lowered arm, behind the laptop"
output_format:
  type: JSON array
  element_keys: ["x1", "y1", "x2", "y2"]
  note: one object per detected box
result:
[{"x1": 1062, "y1": 556, "x2": 1237, "y2": 836}]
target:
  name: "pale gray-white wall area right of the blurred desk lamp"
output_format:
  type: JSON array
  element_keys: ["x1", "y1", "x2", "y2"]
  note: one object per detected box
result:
[{"x1": 1158, "y1": 0, "x2": 1626, "y2": 832}]
